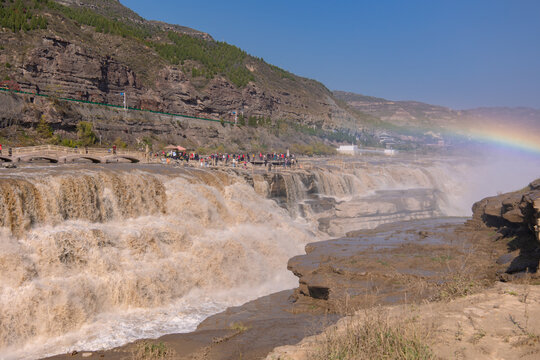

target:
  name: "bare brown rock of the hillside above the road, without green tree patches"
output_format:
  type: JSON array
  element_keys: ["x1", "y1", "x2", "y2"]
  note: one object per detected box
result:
[{"x1": 0, "y1": 0, "x2": 358, "y2": 134}]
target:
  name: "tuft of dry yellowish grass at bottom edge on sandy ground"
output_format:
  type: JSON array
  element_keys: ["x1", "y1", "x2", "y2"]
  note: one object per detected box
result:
[{"x1": 310, "y1": 309, "x2": 435, "y2": 360}]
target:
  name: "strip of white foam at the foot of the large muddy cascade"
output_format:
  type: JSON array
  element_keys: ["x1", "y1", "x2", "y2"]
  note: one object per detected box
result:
[{"x1": 5, "y1": 280, "x2": 296, "y2": 360}]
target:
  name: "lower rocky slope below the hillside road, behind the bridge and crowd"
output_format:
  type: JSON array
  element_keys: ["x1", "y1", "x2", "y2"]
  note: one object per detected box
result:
[{"x1": 0, "y1": 92, "x2": 311, "y2": 152}]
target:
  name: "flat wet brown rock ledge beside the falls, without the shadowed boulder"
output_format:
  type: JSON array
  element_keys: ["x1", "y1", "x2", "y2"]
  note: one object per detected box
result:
[{"x1": 288, "y1": 218, "x2": 506, "y2": 312}]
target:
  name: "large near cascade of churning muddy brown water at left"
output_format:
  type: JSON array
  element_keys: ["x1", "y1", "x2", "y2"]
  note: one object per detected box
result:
[{"x1": 0, "y1": 170, "x2": 316, "y2": 359}]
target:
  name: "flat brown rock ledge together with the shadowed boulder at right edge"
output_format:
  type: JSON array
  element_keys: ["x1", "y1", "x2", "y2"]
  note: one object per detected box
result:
[{"x1": 288, "y1": 179, "x2": 540, "y2": 309}]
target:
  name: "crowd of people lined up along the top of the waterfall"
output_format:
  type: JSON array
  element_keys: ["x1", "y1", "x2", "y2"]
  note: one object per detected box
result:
[{"x1": 153, "y1": 150, "x2": 297, "y2": 169}]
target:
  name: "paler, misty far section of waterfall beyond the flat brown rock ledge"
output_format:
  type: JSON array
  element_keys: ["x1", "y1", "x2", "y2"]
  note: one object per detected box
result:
[{"x1": 271, "y1": 160, "x2": 470, "y2": 236}]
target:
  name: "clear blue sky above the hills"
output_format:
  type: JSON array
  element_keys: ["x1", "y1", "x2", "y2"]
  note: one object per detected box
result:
[{"x1": 121, "y1": 0, "x2": 540, "y2": 109}]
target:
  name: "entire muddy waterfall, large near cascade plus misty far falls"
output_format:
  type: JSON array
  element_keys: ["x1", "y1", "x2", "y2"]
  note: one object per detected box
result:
[{"x1": 0, "y1": 153, "x2": 532, "y2": 359}]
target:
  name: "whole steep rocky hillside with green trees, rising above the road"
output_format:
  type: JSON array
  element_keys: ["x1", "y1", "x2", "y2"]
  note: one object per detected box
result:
[{"x1": 0, "y1": 0, "x2": 357, "y2": 150}]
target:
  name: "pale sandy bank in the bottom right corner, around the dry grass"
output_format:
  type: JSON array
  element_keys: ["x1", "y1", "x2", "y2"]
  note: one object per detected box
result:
[{"x1": 266, "y1": 283, "x2": 540, "y2": 360}]
